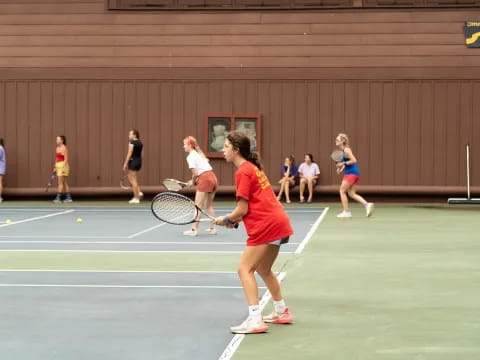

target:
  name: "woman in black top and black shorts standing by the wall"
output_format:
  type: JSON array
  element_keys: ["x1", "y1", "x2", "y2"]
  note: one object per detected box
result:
[{"x1": 123, "y1": 130, "x2": 143, "y2": 204}]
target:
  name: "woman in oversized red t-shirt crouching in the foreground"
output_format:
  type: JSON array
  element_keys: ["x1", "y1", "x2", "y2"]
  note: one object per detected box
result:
[{"x1": 216, "y1": 132, "x2": 293, "y2": 334}]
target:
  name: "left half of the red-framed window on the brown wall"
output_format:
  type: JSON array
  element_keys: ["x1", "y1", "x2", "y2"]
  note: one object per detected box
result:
[{"x1": 205, "y1": 114, "x2": 233, "y2": 158}]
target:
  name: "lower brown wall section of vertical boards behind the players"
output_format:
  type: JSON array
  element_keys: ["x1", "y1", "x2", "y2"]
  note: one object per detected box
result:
[{"x1": 0, "y1": 80, "x2": 479, "y2": 191}]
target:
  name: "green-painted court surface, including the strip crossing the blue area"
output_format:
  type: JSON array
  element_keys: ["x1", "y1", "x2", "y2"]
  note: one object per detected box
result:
[{"x1": 0, "y1": 202, "x2": 480, "y2": 360}]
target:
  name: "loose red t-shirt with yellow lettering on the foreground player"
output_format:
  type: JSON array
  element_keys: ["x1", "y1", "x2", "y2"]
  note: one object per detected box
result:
[{"x1": 235, "y1": 161, "x2": 293, "y2": 246}]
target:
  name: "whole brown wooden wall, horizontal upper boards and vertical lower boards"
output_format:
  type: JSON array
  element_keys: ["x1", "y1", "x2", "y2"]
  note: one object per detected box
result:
[{"x1": 0, "y1": 0, "x2": 480, "y2": 194}]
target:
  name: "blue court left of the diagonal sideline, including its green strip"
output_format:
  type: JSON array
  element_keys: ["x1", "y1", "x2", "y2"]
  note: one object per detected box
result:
[{"x1": 0, "y1": 202, "x2": 326, "y2": 359}]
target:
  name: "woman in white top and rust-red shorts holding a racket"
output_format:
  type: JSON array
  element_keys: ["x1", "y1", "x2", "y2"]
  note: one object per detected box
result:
[{"x1": 183, "y1": 136, "x2": 218, "y2": 236}]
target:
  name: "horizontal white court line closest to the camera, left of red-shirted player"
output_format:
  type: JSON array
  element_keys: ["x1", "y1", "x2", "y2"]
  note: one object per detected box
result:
[{"x1": 0, "y1": 284, "x2": 265, "y2": 289}]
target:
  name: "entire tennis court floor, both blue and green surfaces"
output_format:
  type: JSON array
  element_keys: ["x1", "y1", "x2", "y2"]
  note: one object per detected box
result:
[{"x1": 0, "y1": 204, "x2": 480, "y2": 360}]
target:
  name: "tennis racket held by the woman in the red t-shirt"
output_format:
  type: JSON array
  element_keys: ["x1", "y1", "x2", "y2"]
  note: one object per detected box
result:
[{"x1": 151, "y1": 192, "x2": 238, "y2": 229}]
